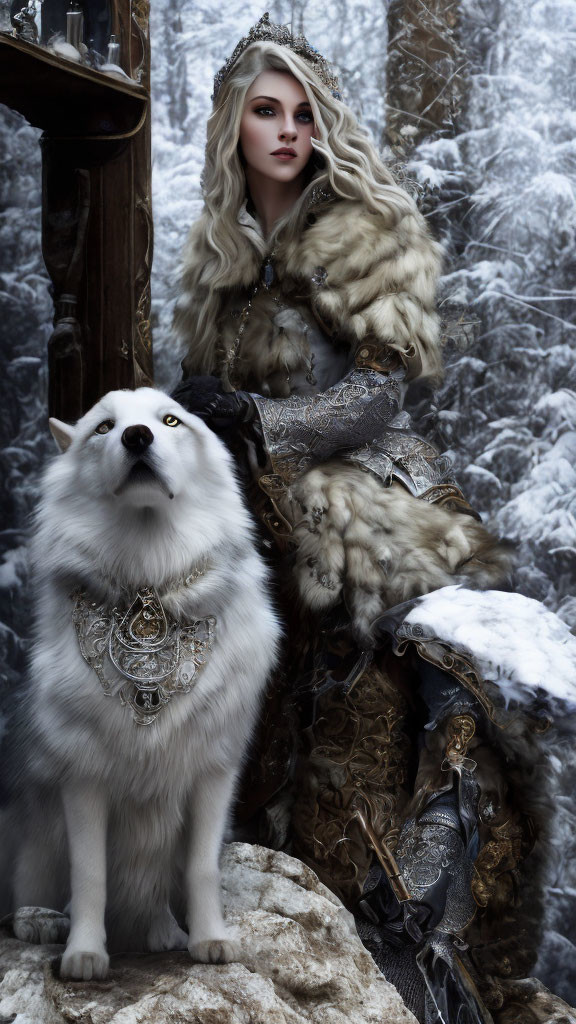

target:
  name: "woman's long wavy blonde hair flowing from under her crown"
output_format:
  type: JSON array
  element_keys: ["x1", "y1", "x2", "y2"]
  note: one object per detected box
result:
[{"x1": 174, "y1": 42, "x2": 414, "y2": 373}]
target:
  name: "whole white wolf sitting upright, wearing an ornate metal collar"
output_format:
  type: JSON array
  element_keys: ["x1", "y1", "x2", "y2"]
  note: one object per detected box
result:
[{"x1": 6, "y1": 388, "x2": 279, "y2": 980}]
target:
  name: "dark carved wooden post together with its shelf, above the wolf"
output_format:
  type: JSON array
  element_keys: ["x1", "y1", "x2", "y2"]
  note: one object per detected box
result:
[{"x1": 0, "y1": 0, "x2": 153, "y2": 421}]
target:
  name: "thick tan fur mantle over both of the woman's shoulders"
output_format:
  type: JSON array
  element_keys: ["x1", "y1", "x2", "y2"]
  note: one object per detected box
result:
[{"x1": 174, "y1": 194, "x2": 442, "y2": 380}]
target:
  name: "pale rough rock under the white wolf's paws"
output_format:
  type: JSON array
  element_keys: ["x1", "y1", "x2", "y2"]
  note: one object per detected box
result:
[{"x1": 0, "y1": 843, "x2": 416, "y2": 1024}]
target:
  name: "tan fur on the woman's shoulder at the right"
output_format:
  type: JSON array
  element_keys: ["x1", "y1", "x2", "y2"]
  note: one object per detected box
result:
[{"x1": 288, "y1": 200, "x2": 442, "y2": 381}]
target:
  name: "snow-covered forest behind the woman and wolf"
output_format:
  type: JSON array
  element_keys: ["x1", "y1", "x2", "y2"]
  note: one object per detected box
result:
[{"x1": 0, "y1": 0, "x2": 576, "y2": 1005}]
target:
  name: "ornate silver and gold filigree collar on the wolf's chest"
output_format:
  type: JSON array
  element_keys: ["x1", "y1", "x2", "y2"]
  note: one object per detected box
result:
[{"x1": 72, "y1": 567, "x2": 216, "y2": 725}]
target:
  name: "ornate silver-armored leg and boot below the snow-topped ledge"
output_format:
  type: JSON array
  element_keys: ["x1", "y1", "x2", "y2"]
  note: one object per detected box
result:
[{"x1": 357, "y1": 662, "x2": 532, "y2": 1024}]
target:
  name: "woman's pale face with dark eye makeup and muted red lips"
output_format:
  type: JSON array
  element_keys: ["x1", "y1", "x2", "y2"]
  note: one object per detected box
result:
[{"x1": 240, "y1": 71, "x2": 315, "y2": 182}]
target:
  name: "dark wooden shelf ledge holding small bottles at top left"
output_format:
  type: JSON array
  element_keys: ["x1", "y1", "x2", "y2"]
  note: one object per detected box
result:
[{"x1": 0, "y1": 33, "x2": 145, "y2": 139}]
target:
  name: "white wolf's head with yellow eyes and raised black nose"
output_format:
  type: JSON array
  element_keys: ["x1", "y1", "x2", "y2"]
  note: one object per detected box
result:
[{"x1": 33, "y1": 388, "x2": 252, "y2": 585}]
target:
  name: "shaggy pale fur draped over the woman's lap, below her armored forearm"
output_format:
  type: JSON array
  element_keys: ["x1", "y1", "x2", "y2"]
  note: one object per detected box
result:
[{"x1": 289, "y1": 459, "x2": 510, "y2": 636}]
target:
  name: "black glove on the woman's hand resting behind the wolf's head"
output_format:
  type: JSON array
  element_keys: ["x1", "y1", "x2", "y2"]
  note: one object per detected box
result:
[{"x1": 168, "y1": 375, "x2": 256, "y2": 433}]
